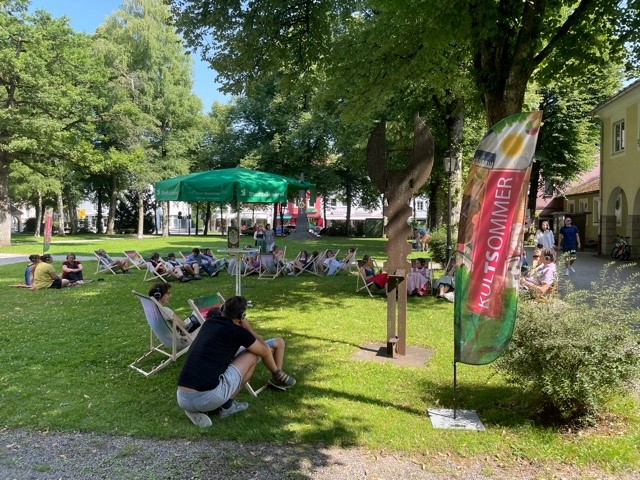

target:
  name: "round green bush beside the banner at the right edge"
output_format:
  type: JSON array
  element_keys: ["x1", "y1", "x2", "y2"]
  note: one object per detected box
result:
[{"x1": 494, "y1": 266, "x2": 640, "y2": 426}]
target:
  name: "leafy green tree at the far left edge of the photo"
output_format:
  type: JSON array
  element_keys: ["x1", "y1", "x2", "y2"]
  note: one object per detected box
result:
[{"x1": 0, "y1": 0, "x2": 101, "y2": 246}]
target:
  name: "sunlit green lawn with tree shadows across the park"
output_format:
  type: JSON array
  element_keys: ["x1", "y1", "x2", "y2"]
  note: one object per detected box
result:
[{"x1": 0, "y1": 232, "x2": 640, "y2": 471}]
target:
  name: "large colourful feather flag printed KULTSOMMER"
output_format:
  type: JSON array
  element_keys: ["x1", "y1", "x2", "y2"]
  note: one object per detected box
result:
[{"x1": 454, "y1": 111, "x2": 542, "y2": 365}]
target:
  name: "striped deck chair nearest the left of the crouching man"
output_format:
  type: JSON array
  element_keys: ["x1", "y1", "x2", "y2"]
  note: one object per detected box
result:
[{"x1": 129, "y1": 290, "x2": 195, "y2": 377}]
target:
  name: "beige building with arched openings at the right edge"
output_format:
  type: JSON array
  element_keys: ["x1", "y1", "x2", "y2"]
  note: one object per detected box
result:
[{"x1": 593, "y1": 80, "x2": 640, "y2": 257}]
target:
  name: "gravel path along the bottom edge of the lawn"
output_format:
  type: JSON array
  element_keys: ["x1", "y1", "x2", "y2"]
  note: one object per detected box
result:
[{"x1": 0, "y1": 428, "x2": 640, "y2": 480}]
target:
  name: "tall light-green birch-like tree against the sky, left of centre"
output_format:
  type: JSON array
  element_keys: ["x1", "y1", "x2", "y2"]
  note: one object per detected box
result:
[{"x1": 96, "y1": 0, "x2": 202, "y2": 237}]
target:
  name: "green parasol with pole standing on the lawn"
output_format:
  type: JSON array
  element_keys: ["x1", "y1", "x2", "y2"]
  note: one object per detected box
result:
[{"x1": 155, "y1": 167, "x2": 316, "y2": 295}]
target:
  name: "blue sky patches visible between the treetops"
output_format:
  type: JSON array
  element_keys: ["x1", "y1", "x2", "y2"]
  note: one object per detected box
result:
[{"x1": 30, "y1": 0, "x2": 229, "y2": 112}]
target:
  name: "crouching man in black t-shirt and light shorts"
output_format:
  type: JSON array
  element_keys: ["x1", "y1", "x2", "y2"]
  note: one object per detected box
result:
[{"x1": 177, "y1": 296, "x2": 296, "y2": 427}]
